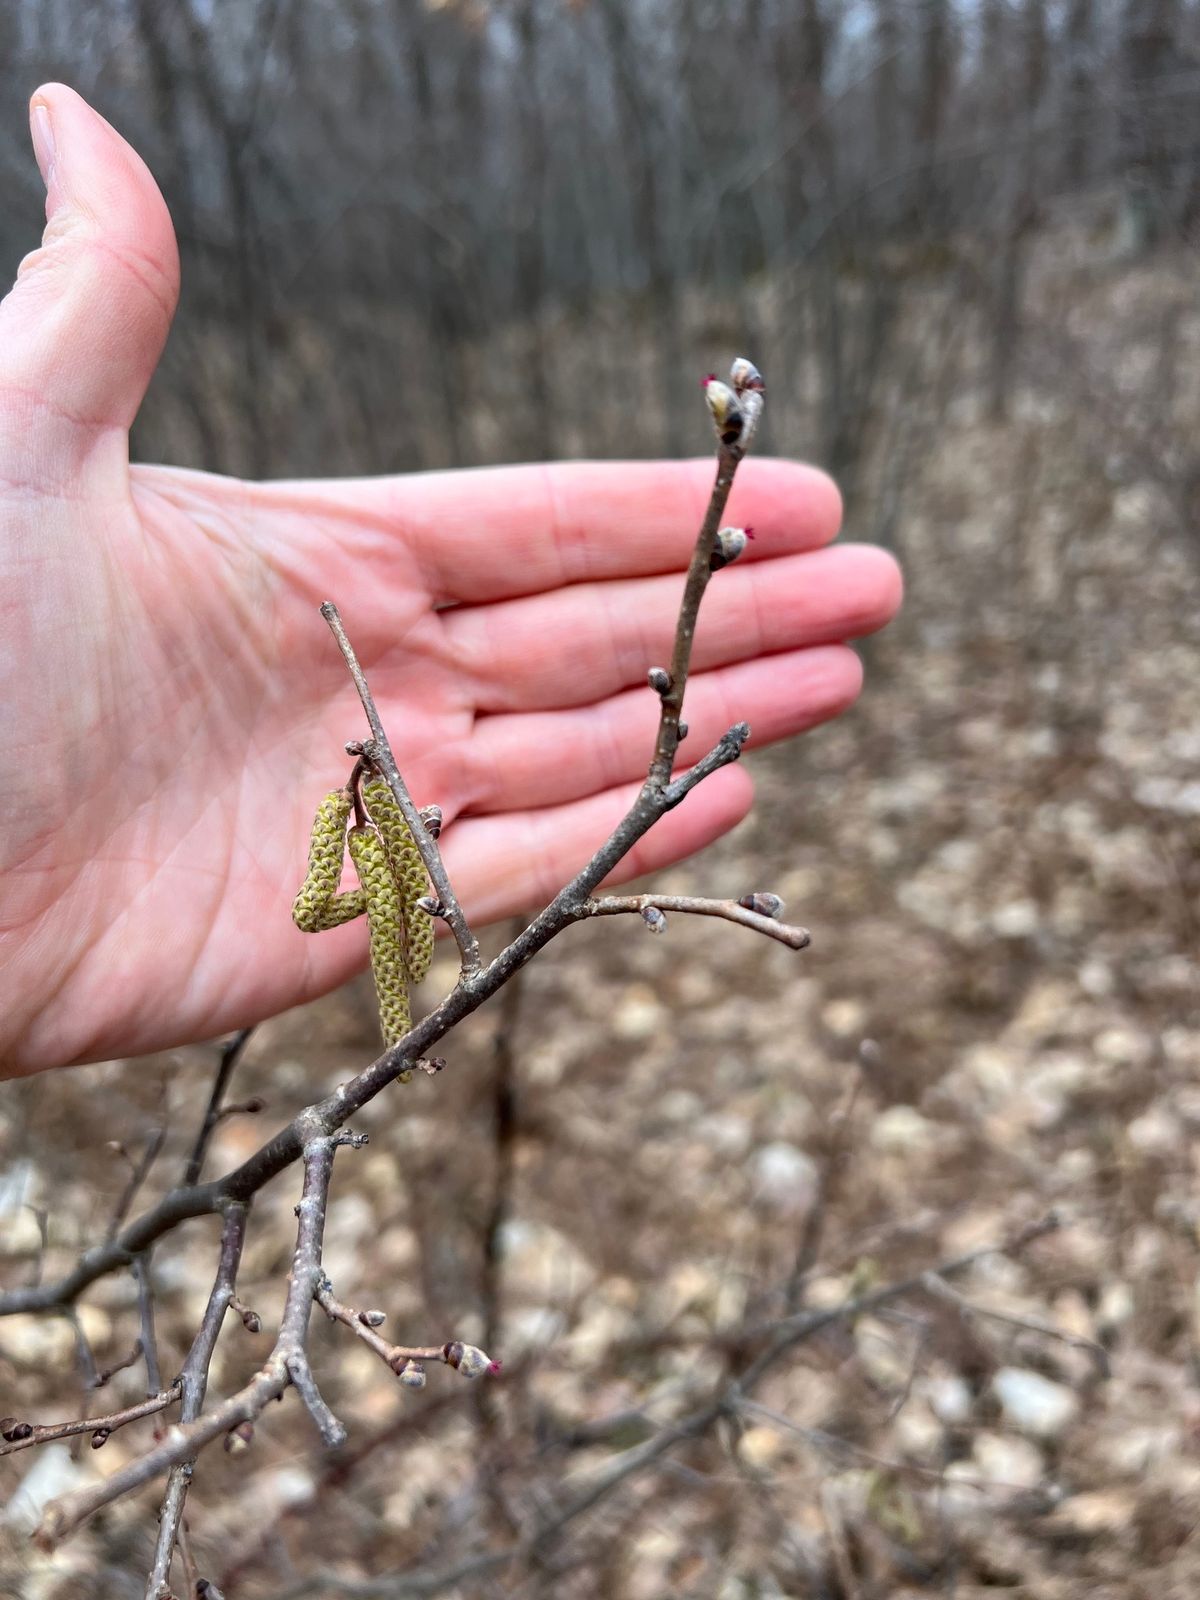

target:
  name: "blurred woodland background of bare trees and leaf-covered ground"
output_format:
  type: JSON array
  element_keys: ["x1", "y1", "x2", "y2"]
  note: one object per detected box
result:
[{"x1": 0, "y1": 0, "x2": 1200, "y2": 1600}]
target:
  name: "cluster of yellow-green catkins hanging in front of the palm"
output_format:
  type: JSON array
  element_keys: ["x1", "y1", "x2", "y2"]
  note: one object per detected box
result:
[{"x1": 291, "y1": 778, "x2": 434, "y2": 1045}]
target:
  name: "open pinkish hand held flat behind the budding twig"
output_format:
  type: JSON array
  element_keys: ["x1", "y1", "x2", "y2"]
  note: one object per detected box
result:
[{"x1": 0, "y1": 85, "x2": 901, "y2": 1075}]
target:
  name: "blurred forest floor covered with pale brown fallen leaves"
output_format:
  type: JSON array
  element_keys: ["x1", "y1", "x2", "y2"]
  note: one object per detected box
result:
[{"x1": 0, "y1": 228, "x2": 1200, "y2": 1600}]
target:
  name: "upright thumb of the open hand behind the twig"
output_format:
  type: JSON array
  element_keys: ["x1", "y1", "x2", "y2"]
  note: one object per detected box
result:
[{"x1": 0, "y1": 83, "x2": 179, "y2": 453}]
